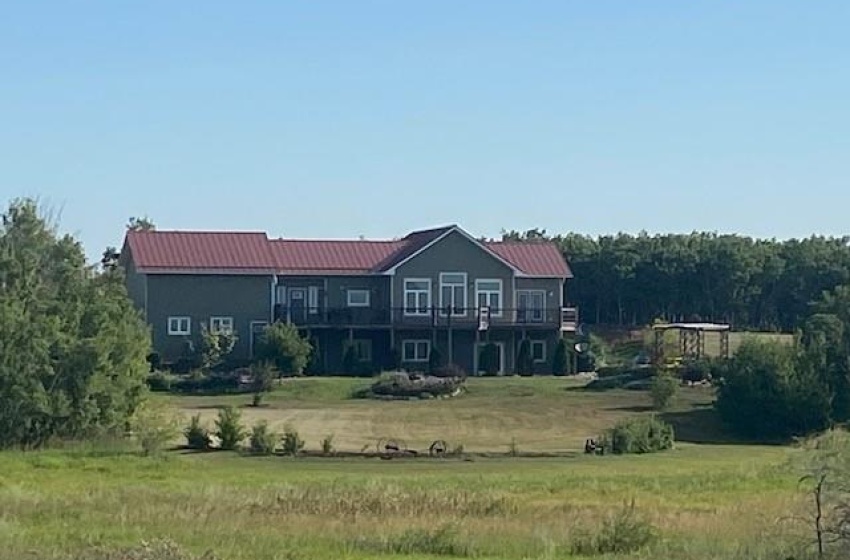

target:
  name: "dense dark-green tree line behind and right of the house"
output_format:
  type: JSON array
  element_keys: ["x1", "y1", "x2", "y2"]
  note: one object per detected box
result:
[{"x1": 502, "y1": 229, "x2": 850, "y2": 331}]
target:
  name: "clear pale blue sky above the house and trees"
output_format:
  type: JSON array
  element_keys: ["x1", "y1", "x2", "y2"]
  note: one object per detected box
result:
[{"x1": 0, "y1": 0, "x2": 850, "y2": 255}]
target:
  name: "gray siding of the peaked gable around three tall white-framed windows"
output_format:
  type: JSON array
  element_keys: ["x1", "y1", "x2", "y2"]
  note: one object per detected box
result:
[{"x1": 393, "y1": 232, "x2": 514, "y2": 324}]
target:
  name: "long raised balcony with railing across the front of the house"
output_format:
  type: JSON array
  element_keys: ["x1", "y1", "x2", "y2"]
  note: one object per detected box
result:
[{"x1": 274, "y1": 305, "x2": 578, "y2": 331}]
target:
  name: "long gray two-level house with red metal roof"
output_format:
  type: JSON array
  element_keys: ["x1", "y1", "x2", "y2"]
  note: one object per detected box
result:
[{"x1": 121, "y1": 225, "x2": 577, "y2": 373}]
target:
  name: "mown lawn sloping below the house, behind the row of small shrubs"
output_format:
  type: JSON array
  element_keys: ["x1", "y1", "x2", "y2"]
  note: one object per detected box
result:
[{"x1": 169, "y1": 377, "x2": 728, "y2": 453}]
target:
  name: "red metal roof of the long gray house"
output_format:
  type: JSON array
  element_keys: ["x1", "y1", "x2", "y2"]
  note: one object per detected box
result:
[{"x1": 125, "y1": 226, "x2": 572, "y2": 278}]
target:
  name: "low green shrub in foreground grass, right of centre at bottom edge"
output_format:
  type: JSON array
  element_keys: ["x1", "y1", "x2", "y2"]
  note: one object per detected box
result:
[{"x1": 572, "y1": 501, "x2": 658, "y2": 556}]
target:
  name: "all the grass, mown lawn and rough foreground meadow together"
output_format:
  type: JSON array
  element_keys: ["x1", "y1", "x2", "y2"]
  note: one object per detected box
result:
[{"x1": 0, "y1": 378, "x2": 800, "y2": 560}]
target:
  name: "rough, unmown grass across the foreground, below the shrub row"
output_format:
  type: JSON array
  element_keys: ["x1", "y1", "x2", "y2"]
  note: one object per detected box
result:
[{"x1": 0, "y1": 445, "x2": 796, "y2": 559}]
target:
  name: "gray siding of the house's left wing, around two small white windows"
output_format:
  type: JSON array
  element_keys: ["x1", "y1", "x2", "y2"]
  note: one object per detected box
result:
[{"x1": 147, "y1": 275, "x2": 272, "y2": 360}]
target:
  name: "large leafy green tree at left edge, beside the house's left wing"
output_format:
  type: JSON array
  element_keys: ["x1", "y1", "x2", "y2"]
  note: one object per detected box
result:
[{"x1": 0, "y1": 200, "x2": 150, "y2": 448}]
